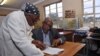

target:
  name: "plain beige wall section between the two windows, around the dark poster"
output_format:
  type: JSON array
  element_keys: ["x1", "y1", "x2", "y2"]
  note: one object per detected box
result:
[{"x1": 62, "y1": 0, "x2": 83, "y2": 17}]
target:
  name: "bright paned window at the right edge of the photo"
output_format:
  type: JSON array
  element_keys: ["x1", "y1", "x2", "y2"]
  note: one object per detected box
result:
[{"x1": 83, "y1": 0, "x2": 100, "y2": 27}]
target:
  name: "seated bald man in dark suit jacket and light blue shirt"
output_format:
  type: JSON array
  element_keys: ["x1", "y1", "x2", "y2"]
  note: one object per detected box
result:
[{"x1": 32, "y1": 18, "x2": 66, "y2": 46}]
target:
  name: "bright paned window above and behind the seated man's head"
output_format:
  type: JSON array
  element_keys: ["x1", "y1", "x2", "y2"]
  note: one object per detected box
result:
[{"x1": 45, "y1": 2, "x2": 63, "y2": 17}]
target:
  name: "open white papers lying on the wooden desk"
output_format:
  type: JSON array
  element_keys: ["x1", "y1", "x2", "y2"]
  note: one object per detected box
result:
[{"x1": 43, "y1": 47, "x2": 64, "y2": 55}]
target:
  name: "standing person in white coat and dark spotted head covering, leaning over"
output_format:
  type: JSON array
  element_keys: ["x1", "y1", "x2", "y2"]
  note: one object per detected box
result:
[{"x1": 0, "y1": 3, "x2": 44, "y2": 56}]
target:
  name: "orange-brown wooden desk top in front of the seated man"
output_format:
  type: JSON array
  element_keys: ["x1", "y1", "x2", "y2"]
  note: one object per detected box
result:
[{"x1": 47, "y1": 42, "x2": 85, "y2": 56}]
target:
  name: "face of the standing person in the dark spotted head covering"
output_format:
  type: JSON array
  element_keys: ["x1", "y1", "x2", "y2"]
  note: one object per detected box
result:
[{"x1": 26, "y1": 13, "x2": 39, "y2": 26}]
